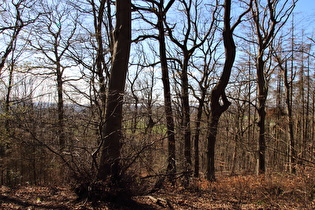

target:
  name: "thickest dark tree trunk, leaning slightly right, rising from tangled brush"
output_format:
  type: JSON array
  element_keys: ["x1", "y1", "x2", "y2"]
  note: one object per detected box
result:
[{"x1": 97, "y1": 0, "x2": 131, "y2": 184}]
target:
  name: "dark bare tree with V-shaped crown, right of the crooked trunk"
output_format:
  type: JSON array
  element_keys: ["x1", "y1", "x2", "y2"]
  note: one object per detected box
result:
[{"x1": 251, "y1": 0, "x2": 297, "y2": 174}]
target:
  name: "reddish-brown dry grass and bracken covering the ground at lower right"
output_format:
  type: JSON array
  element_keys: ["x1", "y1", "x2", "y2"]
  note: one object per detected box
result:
[{"x1": 144, "y1": 168, "x2": 315, "y2": 209}]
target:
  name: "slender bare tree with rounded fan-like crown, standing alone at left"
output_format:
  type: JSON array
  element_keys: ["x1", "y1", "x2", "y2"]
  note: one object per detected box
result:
[{"x1": 29, "y1": 1, "x2": 77, "y2": 151}]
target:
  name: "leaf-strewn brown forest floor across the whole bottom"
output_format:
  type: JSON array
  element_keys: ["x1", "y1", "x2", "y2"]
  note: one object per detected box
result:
[{"x1": 0, "y1": 172, "x2": 315, "y2": 210}]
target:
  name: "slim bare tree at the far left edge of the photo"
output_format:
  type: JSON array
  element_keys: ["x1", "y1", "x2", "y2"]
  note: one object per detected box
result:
[{"x1": 0, "y1": 0, "x2": 40, "y2": 184}]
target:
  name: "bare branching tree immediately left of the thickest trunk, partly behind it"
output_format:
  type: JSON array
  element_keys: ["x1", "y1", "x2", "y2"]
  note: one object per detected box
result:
[{"x1": 65, "y1": 0, "x2": 115, "y2": 157}]
